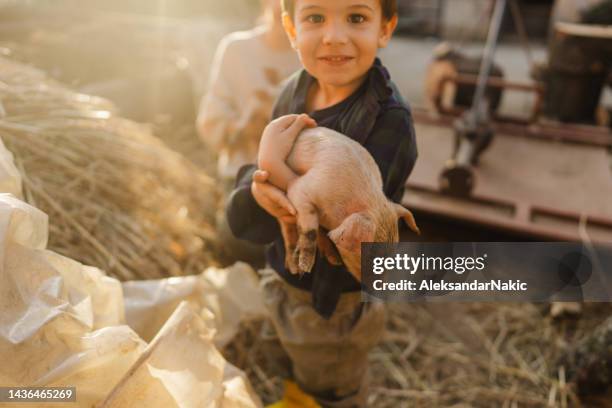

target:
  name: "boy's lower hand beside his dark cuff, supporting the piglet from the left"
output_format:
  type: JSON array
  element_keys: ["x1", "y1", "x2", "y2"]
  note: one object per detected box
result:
[{"x1": 251, "y1": 170, "x2": 296, "y2": 224}]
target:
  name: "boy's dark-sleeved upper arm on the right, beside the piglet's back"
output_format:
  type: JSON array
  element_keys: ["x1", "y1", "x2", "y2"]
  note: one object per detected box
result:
[{"x1": 365, "y1": 108, "x2": 418, "y2": 203}]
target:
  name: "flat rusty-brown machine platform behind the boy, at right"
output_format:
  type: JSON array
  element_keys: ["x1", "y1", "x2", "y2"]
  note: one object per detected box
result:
[{"x1": 404, "y1": 124, "x2": 612, "y2": 242}]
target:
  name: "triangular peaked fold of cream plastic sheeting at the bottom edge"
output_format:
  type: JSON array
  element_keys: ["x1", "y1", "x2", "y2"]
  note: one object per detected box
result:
[{"x1": 100, "y1": 302, "x2": 262, "y2": 408}]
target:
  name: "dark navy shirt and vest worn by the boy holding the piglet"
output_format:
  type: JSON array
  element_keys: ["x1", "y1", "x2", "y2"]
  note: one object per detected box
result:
[{"x1": 226, "y1": 59, "x2": 417, "y2": 318}]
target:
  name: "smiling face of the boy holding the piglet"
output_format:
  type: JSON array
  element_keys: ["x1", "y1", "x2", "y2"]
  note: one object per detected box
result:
[{"x1": 283, "y1": 0, "x2": 397, "y2": 87}]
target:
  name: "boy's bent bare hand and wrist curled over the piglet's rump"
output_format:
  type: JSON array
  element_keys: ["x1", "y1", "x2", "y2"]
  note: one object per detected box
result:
[{"x1": 257, "y1": 114, "x2": 316, "y2": 191}]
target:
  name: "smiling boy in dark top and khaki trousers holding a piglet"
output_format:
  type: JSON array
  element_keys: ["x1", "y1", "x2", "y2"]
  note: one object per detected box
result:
[{"x1": 226, "y1": 0, "x2": 417, "y2": 407}]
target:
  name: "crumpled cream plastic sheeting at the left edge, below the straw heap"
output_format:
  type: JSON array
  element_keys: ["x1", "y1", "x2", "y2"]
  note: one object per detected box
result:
[{"x1": 0, "y1": 194, "x2": 145, "y2": 407}]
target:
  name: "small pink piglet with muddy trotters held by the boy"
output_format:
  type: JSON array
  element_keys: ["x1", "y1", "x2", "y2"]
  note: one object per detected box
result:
[{"x1": 258, "y1": 118, "x2": 419, "y2": 280}]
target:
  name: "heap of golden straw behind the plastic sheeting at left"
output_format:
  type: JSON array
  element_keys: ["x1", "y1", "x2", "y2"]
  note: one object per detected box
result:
[{"x1": 0, "y1": 59, "x2": 219, "y2": 280}]
